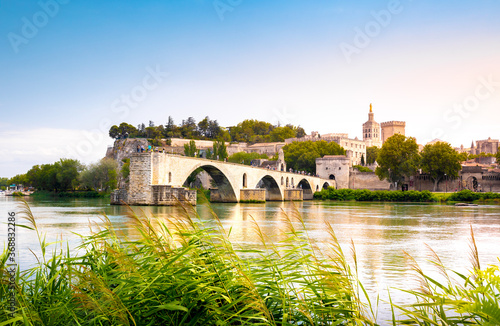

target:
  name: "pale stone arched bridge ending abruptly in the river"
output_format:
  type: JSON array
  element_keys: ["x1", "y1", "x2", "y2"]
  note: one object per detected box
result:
[{"x1": 111, "y1": 152, "x2": 335, "y2": 205}]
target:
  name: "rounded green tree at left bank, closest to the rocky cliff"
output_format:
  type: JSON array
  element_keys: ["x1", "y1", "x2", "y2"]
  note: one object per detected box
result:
[{"x1": 79, "y1": 158, "x2": 118, "y2": 192}]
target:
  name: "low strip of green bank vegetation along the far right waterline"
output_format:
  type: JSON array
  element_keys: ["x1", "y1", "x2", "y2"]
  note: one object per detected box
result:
[{"x1": 314, "y1": 187, "x2": 500, "y2": 202}]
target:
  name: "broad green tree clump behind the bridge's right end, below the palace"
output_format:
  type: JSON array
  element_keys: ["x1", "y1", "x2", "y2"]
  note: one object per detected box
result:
[{"x1": 283, "y1": 140, "x2": 345, "y2": 173}]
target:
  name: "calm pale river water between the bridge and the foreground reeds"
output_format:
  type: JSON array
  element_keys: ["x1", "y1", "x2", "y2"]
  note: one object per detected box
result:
[{"x1": 0, "y1": 197, "x2": 500, "y2": 324}]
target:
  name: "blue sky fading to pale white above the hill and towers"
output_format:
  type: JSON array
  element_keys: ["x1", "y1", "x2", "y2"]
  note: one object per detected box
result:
[{"x1": 0, "y1": 0, "x2": 500, "y2": 177}]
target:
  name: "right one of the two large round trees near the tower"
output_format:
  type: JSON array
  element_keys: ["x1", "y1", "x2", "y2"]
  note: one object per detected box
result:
[{"x1": 420, "y1": 142, "x2": 462, "y2": 191}]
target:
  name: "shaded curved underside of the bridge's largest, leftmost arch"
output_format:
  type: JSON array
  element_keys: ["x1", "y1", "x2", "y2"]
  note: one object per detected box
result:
[{"x1": 184, "y1": 164, "x2": 238, "y2": 203}]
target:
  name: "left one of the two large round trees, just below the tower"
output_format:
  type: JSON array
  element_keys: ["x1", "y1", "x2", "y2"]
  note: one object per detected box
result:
[{"x1": 375, "y1": 134, "x2": 420, "y2": 188}]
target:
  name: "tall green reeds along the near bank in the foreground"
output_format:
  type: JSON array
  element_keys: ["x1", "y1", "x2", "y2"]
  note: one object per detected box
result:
[{"x1": 0, "y1": 202, "x2": 500, "y2": 325}]
